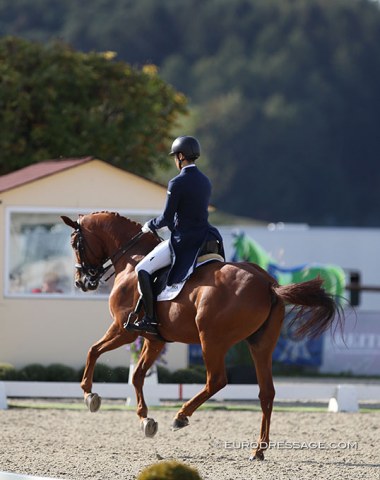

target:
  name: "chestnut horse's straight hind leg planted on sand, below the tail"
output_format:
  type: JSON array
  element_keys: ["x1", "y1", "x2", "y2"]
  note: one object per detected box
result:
[{"x1": 248, "y1": 301, "x2": 284, "y2": 460}]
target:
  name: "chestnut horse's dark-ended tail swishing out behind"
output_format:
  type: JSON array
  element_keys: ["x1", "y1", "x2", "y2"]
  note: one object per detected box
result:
[{"x1": 273, "y1": 277, "x2": 344, "y2": 338}]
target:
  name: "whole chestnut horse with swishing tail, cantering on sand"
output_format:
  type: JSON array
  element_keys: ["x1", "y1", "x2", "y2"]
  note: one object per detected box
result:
[{"x1": 62, "y1": 212, "x2": 342, "y2": 459}]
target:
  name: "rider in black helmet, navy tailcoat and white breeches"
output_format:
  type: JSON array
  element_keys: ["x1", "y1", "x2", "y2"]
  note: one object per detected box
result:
[{"x1": 127, "y1": 136, "x2": 224, "y2": 333}]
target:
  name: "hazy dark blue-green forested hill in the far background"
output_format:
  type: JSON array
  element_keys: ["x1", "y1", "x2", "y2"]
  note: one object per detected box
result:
[{"x1": 0, "y1": 0, "x2": 380, "y2": 226}]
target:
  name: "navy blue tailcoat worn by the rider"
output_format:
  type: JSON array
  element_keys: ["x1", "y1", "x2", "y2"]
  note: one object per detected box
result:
[{"x1": 148, "y1": 165, "x2": 224, "y2": 285}]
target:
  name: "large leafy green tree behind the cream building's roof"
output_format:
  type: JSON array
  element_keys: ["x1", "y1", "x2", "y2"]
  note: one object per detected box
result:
[{"x1": 0, "y1": 37, "x2": 186, "y2": 176}]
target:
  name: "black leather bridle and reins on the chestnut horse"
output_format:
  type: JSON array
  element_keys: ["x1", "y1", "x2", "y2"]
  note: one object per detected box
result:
[{"x1": 73, "y1": 222, "x2": 144, "y2": 290}]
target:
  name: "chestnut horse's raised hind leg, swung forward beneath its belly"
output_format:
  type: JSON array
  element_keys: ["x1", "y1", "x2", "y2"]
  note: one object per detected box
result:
[{"x1": 173, "y1": 345, "x2": 227, "y2": 430}]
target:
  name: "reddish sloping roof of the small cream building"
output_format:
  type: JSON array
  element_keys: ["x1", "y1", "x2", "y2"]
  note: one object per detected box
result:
[{"x1": 0, "y1": 157, "x2": 94, "y2": 193}]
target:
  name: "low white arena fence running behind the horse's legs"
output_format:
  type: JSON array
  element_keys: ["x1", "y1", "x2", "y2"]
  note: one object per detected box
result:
[{"x1": 0, "y1": 379, "x2": 380, "y2": 411}]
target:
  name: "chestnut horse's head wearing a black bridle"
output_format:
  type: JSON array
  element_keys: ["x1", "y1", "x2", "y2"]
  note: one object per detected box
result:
[{"x1": 61, "y1": 216, "x2": 106, "y2": 292}]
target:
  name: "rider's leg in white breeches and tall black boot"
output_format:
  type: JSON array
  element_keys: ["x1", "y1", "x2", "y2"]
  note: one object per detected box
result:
[{"x1": 127, "y1": 240, "x2": 171, "y2": 333}]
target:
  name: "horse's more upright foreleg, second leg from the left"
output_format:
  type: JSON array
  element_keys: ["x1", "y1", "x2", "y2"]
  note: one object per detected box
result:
[{"x1": 132, "y1": 340, "x2": 165, "y2": 437}]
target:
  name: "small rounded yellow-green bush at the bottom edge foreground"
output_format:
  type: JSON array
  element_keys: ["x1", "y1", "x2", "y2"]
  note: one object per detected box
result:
[{"x1": 137, "y1": 460, "x2": 201, "y2": 480}]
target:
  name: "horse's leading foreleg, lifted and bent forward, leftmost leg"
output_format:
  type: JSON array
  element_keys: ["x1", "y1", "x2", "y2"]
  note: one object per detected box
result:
[{"x1": 80, "y1": 322, "x2": 137, "y2": 412}]
